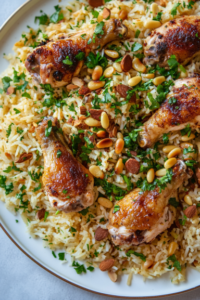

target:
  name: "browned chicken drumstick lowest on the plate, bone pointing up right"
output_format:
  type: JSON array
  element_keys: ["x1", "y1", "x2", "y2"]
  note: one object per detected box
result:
[{"x1": 108, "y1": 160, "x2": 186, "y2": 245}]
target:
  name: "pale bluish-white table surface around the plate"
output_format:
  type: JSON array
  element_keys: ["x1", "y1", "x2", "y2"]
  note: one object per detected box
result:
[{"x1": 0, "y1": 0, "x2": 200, "y2": 300}]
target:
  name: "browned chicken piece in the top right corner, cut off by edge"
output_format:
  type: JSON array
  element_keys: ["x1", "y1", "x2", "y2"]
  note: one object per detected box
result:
[{"x1": 144, "y1": 16, "x2": 200, "y2": 67}]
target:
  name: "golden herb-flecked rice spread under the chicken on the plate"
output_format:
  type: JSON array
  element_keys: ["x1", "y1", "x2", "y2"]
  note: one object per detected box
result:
[{"x1": 0, "y1": 0, "x2": 200, "y2": 285}]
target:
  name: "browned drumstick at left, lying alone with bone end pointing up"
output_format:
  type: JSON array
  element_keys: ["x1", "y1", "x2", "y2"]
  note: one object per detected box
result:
[{"x1": 36, "y1": 118, "x2": 94, "y2": 213}]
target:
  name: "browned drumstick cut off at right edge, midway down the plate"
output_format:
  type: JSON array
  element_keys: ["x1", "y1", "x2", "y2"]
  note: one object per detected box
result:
[{"x1": 138, "y1": 74, "x2": 200, "y2": 148}]
